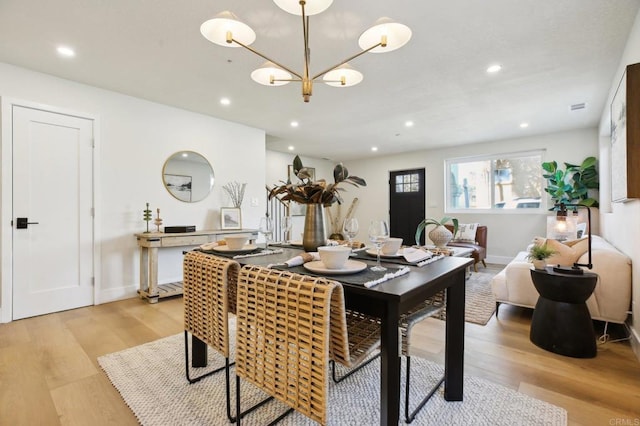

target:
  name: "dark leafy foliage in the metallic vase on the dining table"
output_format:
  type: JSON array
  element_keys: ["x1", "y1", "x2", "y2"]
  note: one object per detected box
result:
[{"x1": 269, "y1": 155, "x2": 367, "y2": 207}]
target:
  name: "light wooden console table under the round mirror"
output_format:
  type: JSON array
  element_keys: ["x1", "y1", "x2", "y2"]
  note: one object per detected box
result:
[{"x1": 135, "y1": 229, "x2": 258, "y2": 303}]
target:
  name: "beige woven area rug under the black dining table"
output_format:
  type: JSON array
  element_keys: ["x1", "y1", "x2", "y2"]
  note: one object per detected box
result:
[{"x1": 98, "y1": 334, "x2": 567, "y2": 426}]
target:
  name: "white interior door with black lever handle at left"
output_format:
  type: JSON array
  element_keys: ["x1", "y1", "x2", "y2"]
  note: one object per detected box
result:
[{"x1": 12, "y1": 105, "x2": 94, "y2": 319}]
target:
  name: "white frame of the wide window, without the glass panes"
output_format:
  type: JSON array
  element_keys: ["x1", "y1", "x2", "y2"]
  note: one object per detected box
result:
[{"x1": 444, "y1": 149, "x2": 548, "y2": 215}]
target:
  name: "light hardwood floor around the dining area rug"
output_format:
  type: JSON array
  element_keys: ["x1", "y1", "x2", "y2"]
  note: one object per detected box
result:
[{"x1": 0, "y1": 297, "x2": 640, "y2": 426}]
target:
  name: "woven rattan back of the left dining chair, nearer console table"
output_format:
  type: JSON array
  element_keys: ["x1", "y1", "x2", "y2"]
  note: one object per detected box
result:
[{"x1": 182, "y1": 251, "x2": 240, "y2": 358}]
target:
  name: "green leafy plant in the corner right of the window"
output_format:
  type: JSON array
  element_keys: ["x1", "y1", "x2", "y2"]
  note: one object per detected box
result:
[{"x1": 542, "y1": 157, "x2": 600, "y2": 207}]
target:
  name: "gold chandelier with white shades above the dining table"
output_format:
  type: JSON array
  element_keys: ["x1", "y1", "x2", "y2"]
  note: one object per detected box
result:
[{"x1": 200, "y1": 0, "x2": 411, "y2": 102}]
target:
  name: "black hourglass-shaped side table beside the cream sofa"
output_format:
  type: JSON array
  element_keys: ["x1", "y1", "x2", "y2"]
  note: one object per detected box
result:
[{"x1": 529, "y1": 266, "x2": 598, "y2": 358}]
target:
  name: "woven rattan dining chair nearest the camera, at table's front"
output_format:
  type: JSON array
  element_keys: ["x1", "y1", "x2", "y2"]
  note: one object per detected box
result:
[{"x1": 235, "y1": 266, "x2": 378, "y2": 425}]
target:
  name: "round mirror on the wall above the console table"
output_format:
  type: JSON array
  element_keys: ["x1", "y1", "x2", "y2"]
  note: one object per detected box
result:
[{"x1": 162, "y1": 151, "x2": 214, "y2": 203}]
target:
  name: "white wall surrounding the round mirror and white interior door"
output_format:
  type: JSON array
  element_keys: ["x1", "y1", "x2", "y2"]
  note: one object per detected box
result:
[{"x1": 0, "y1": 63, "x2": 265, "y2": 320}]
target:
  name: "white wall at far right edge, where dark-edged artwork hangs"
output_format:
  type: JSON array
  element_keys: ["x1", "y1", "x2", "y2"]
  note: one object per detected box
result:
[{"x1": 599, "y1": 7, "x2": 640, "y2": 359}]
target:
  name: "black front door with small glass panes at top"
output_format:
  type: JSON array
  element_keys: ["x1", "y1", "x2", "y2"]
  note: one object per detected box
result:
[{"x1": 389, "y1": 169, "x2": 425, "y2": 245}]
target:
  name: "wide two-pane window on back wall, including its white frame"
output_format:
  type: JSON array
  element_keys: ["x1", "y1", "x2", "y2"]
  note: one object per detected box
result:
[{"x1": 445, "y1": 151, "x2": 544, "y2": 211}]
